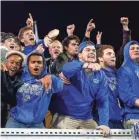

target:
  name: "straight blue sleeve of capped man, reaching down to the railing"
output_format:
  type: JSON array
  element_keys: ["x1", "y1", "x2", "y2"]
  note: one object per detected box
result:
[{"x1": 96, "y1": 74, "x2": 109, "y2": 126}]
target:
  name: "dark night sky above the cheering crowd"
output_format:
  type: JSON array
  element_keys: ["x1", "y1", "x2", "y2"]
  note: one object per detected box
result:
[{"x1": 1, "y1": 1, "x2": 139, "y2": 52}]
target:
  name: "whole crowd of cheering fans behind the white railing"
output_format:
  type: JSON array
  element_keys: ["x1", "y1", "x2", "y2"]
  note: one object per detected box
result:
[{"x1": 0, "y1": 14, "x2": 139, "y2": 136}]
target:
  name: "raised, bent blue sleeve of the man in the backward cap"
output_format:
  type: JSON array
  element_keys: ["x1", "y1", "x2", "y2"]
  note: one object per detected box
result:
[{"x1": 62, "y1": 61, "x2": 84, "y2": 78}]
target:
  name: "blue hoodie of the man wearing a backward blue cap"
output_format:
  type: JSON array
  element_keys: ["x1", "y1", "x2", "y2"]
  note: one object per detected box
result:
[{"x1": 50, "y1": 61, "x2": 109, "y2": 125}]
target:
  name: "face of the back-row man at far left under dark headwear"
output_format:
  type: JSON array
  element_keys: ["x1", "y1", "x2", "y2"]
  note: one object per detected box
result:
[{"x1": 2, "y1": 38, "x2": 16, "y2": 51}]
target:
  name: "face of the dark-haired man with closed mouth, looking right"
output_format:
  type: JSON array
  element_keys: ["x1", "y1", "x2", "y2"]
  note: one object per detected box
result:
[{"x1": 65, "y1": 40, "x2": 79, "y2": 56}]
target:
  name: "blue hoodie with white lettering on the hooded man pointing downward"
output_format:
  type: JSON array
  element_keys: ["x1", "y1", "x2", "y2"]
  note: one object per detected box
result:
[{"x1": 10, "y1": 53, "x2": 63, "y2": 124}]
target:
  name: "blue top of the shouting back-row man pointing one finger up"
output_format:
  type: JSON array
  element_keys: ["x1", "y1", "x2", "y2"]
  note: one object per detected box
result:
[{"x1": 22, "y1": 40, "x2": 48, "y2": 55}]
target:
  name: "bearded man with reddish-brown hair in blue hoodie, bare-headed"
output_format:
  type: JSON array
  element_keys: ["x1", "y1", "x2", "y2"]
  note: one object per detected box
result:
[{"x1": 97, "y1": 45, "x2": 123, "y2": 129}]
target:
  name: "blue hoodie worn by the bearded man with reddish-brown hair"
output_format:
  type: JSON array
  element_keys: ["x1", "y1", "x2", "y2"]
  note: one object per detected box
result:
[{"x1": 102, "y1": 69, "x2": 122, "y2": 121}]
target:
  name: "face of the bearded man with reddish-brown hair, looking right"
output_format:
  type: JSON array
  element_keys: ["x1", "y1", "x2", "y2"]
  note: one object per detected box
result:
[{"x1": 99, "y1": 48, "x2": 116, "y2": 67}]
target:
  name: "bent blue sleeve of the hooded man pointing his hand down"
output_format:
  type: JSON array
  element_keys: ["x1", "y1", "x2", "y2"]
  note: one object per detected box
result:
[{"x1": 51, "y1": 75, "x2": 63, "y2": 93}]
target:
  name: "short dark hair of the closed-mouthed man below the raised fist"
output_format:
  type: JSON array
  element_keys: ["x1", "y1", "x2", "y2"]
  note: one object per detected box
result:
[{"x1": 62, "y1": 35, "x2": 80, "y2": 48}]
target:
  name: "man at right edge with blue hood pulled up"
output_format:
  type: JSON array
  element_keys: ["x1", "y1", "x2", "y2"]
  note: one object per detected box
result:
[{"x1": 118, "y1": 41, "x2": 139, "y2": 129}]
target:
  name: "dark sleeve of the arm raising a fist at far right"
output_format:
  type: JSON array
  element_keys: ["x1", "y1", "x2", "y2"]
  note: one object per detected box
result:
[{"x1": 116, "y1": 30, "x2": 131, "y2": 68}]
